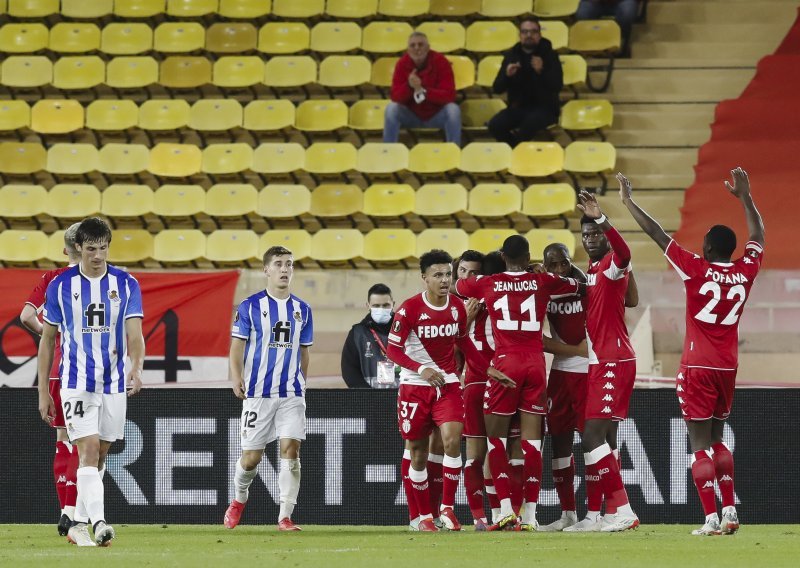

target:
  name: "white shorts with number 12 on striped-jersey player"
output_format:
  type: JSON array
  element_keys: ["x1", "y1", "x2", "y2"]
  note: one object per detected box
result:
[{"x1": 241, "y1": 396, "x2": 306, "y2": 450}]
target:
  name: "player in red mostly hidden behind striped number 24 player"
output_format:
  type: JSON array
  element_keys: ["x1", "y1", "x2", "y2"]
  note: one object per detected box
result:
[{"x1": 19, "y1": 223, "x2": 81, "y2": 536}]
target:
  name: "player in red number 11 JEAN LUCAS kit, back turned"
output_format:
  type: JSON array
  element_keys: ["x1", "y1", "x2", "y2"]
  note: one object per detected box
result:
[{"x1": 456, "y1": 235, "x2": 581, "y2": 530}]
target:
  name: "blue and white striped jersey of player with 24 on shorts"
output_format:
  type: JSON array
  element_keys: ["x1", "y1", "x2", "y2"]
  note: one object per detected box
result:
[{"x1": 43, "y1": 264, "x2": 144, "y2": 394}]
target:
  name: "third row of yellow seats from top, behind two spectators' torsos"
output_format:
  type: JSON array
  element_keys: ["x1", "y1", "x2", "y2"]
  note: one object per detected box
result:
[{"x1": 0, "y1": 55, "x2": 587, "y2": 90}]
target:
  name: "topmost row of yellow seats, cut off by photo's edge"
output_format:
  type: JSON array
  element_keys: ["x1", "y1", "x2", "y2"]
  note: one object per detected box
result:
[{"x1": 0, "y1": 0, "x2": 579, "y2": 19}]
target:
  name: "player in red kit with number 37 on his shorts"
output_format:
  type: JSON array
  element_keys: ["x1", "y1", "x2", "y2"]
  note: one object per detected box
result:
[{"x1": 387, "y1": 250, "x2": 467, "y2": 531}]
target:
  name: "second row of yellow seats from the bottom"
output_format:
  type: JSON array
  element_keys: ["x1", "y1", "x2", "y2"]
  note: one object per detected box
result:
[{"x1": 0, "y1": 183, "x2": 575, "y2": 222}]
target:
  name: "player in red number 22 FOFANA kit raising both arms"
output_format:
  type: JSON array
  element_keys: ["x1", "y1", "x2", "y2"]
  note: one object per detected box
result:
[{"x1": 617, "y1": 168, "x2": 764, "y2": 535}]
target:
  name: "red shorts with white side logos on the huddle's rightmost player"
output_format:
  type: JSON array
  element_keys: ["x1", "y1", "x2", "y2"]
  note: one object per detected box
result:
[{"x1": 585, "y1": 359, "x2": 636, "y2": 421}]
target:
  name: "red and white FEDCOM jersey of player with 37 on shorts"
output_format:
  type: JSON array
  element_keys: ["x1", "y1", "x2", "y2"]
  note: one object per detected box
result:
[{"x1": 387, "y1": 292, "x2": 467, "y2": 386}]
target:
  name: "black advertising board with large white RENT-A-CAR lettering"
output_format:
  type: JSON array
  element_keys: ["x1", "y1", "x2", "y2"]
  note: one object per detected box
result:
[{"x1": 0, "y1": 388, "x2": 800, "y2": 525}]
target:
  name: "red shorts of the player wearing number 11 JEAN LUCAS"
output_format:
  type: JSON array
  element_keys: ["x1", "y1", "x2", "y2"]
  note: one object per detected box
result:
[{"x1": 483, "y1": 351, "x2": 547, "y2": 416}]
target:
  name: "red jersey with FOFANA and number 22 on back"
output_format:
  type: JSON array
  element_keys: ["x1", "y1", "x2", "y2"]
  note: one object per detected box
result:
[{"x1": 664, "y1": 241, "x2": 764, "y2": 370}]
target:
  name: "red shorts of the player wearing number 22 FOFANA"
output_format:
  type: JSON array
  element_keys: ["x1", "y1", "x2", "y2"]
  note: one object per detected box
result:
[{"x1": 675, "y1": 365, "x2": 736, "y2": 420}]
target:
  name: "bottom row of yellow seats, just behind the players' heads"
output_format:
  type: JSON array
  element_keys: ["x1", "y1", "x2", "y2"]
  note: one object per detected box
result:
[{"x1": 0, "y1": 229, "x2": 575, "y2": 265}]
